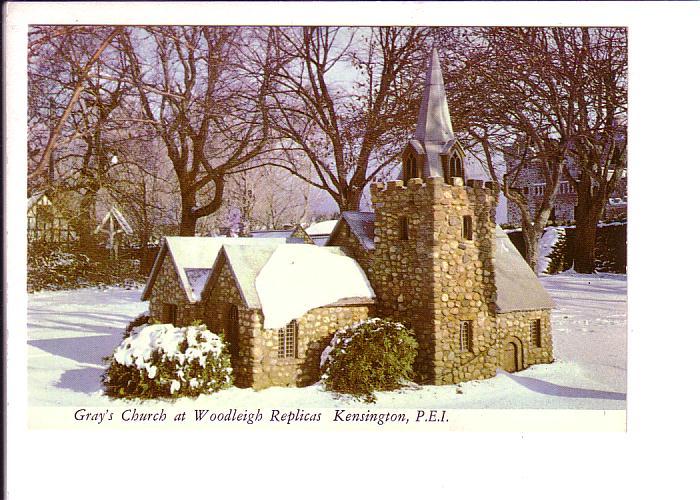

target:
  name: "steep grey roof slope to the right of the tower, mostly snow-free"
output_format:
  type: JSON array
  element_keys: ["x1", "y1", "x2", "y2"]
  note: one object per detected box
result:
[{"x1": 493, "y1": 226, "x2": 554, "y2": 313}]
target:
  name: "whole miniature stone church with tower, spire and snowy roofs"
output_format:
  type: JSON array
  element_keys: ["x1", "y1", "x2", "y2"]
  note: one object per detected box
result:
[{"x1": 142, "y1": 50, "x2": 554, "y2": 389}]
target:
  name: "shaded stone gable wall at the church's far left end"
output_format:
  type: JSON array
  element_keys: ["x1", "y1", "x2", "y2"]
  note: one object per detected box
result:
[{"x1": 149, "y1": 254, "x2": 202, "y2": 326}]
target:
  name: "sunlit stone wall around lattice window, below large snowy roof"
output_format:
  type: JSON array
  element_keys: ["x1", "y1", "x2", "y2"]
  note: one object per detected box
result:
[{"x1": 252, "y1": 304, "x2": 374, "y2": 389}]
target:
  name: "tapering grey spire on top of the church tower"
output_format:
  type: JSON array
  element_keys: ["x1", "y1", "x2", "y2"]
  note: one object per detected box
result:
[{"x1": 414, "y1": 49, "x2": 454, "y2": 145}]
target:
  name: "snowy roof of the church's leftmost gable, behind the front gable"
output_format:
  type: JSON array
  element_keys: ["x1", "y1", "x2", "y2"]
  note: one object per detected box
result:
[{"x1": 141, "y1": 236, "x2": 285, "y2": 303}]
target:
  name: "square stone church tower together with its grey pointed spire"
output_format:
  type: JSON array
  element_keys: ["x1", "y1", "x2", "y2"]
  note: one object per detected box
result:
[{"x1": 369, "y1": 50, "x2": 499, "y2": 384}]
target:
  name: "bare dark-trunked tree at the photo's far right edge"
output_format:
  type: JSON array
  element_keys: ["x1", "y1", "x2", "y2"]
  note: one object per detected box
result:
[{"x1": 557, "y1": 28, "x2": 627, "y2": 273}]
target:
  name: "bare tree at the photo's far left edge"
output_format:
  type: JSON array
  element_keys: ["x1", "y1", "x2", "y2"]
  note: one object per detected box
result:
[{"x1": 28, "y1": 26, "x2": 134, "y2": 251}]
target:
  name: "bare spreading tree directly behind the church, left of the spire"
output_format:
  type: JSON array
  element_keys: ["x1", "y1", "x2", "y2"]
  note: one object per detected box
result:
[{"x1": 269, "y1": 27, "x2": 428, "y2": 211}]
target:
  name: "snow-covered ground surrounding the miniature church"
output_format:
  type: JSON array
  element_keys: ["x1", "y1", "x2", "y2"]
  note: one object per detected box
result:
[{"x1": 27, "y1": 273, "x2": 627, "y2": 410}]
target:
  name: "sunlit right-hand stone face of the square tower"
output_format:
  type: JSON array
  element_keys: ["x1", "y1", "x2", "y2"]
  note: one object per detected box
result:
[{"x1": 433, "y1": 180, "x2": 497, "y2": 384}]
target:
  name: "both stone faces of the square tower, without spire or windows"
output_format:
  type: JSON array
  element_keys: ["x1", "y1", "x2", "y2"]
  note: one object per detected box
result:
[{"x1": 372, "y1": 178, "x2": 498, "y2": 384}]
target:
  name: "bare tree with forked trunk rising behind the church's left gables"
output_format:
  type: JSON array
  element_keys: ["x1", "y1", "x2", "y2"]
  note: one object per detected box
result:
[{"x1": 120, "y1": 26, "x2": 272, "y2": 232}]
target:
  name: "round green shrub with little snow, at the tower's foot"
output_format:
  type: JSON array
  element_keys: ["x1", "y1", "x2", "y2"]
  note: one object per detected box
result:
[{"x1": 321, "y1": 318, "x2": 418, "y2": 401}]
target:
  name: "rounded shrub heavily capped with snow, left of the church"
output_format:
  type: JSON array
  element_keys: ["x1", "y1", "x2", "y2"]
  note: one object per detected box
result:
[{"x1": 102, "y1": 324, "x2": 233, "y2": 398}]
